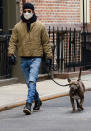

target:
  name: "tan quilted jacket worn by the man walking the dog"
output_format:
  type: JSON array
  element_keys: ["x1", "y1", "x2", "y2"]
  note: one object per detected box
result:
[{"x1": 8, "y1": 21, "x2": 52, "y2": 58}]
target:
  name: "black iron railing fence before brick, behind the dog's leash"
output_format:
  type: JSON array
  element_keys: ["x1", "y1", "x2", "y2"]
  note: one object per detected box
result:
[{"x1": 49, "y1": 27, "x2": 91, "y2": 73}]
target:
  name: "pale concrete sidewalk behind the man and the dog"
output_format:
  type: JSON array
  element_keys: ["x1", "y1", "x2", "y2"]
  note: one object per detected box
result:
[{"x1": 0, "y1": 74, "x2": 91, "y2": 111}]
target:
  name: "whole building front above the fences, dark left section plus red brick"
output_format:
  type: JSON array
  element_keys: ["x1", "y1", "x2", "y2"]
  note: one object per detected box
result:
[{"x1": 0, "y1": 0, "x2": 91, "y2": 31}]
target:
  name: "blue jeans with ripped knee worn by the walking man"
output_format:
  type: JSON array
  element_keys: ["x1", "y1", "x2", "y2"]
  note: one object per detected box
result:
[{"x1": 21, "y1": 58, "x2": 41, "y2": 104}]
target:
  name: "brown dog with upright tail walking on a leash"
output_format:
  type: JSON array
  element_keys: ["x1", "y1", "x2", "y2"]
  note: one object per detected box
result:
[{"x1": 68, "y1": 69, "x2": 85, "y2": 111}]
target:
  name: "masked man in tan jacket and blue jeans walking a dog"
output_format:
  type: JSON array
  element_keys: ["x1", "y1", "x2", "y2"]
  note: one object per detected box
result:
[{"x1": 8, "y1": 3, "x2": 52, "y2": 114}]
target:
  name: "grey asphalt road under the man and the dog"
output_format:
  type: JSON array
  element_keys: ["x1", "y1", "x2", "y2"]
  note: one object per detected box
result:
[{"x1": 0, "y1": 92, "x2": 91, "y2": 131}]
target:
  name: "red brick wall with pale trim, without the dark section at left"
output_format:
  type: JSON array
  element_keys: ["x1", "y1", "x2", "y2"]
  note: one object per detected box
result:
[{"x1": 20, "y1": 0, "x2": 91, "y2": 28}]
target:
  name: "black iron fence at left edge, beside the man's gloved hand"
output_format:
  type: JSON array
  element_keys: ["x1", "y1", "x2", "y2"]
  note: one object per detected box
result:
[{"x1": 0, "y1": 34, "x2": 11, "y2": 79}]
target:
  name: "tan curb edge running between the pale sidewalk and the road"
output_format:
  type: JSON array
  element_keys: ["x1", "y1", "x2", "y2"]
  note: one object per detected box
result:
[{"x1": 0, "y1": 88, "x2": 91, "y2": 112}]
